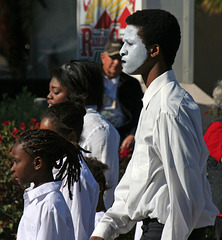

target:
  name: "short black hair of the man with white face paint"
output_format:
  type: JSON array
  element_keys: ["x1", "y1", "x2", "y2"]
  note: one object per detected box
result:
[{"x1": 126, "y1": 9, "x2": 181, "y2": 67}]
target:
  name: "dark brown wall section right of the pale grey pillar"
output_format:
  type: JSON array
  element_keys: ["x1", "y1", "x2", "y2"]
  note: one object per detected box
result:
[{"x1": 194, "y1": 4, "x2": 222, "y2": 96}]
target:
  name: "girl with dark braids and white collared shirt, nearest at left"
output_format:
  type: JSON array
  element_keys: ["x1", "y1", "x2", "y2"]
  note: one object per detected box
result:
[{"x1": 11, "y1": 129, "x2": 82, "y2": 240}]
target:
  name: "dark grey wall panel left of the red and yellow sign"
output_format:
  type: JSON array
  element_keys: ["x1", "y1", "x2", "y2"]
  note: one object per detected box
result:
[{"x1": 30, "y1": 0, "x2": 78, "y2": 79}]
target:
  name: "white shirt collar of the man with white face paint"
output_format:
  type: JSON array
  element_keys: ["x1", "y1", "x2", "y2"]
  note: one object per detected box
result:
[{"x1": 142, "y1": 70, "x2": 176, "y2": 107}]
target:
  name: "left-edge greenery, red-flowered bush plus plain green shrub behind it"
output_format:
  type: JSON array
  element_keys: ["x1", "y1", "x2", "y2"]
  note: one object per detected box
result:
[{"x1": 0, "y1": 88, "x2": 44, "y2": 240}]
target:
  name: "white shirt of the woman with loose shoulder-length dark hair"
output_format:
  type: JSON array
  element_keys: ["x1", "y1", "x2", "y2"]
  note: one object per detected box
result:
[{"x1": 80, "y1": 106, "x2": 120, "y2": 209}]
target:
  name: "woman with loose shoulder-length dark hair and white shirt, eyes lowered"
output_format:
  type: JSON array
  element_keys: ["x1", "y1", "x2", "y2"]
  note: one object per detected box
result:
[{"x1": 47, "y1": 60, "x2": 120, "y2": 209}]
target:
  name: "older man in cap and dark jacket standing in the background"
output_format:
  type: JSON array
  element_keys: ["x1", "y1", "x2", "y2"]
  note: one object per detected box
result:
[{"x1": 100, "y1": 39, "x2": 143, "y2": 150}]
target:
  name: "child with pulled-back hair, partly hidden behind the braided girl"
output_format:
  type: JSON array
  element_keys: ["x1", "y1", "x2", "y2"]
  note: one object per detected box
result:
[{"x1": 40, "y1": 101, "x2": 99, "y2": 240}]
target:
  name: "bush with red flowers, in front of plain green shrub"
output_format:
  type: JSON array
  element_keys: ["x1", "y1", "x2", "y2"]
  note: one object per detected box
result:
[{"x1": 0, "y1": 118, "x2": 39, "y2": 240}]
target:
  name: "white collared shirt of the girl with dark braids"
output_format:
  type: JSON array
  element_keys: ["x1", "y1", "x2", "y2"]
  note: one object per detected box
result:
[{"x1": 17, "y1": 181, "x2": 75, "y2": 240}]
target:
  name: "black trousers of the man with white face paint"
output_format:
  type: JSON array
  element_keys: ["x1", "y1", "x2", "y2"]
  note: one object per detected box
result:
[{"x1": 140, "y1": 218, "x2": 206, "y2": 240}]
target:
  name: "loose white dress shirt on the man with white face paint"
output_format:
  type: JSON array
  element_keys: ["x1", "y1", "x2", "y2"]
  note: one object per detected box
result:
[{"x1": 92, "y1": 70, "x2": 218, "y2": 240}]
